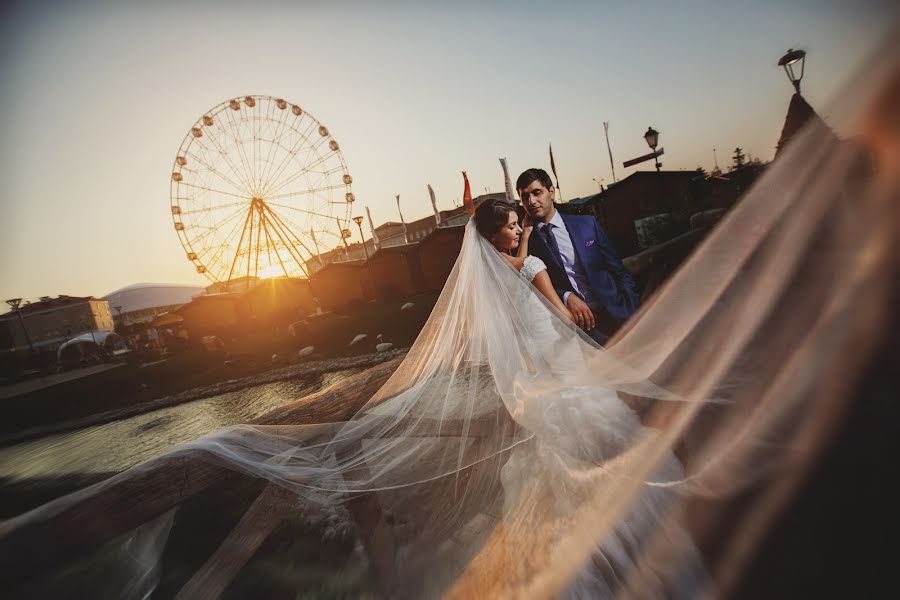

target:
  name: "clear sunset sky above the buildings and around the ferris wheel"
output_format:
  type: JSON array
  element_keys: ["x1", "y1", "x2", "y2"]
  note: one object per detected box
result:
[{"x1": 0, "y1": 0, "x2": 897, "y2": 299}]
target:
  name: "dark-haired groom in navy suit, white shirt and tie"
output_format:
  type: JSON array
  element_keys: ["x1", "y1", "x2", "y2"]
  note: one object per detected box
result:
[{"x1": 516, "y1": 169, "x2": 638, "y2": 344}]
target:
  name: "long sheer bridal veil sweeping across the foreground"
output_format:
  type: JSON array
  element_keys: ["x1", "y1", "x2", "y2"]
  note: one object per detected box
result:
[{"x1": 0, "y1": 36, "x2": 900, "y2": 598}]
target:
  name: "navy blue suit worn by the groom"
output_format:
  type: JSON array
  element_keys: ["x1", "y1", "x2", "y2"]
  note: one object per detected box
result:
[{"x1": 528, "y1": 213, "x2": 639, "y2": 343}]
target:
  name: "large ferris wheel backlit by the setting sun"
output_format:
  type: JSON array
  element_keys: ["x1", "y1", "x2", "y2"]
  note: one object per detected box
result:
[{"x1": 169, "y1": 96, "x2": 355, "y2": 282}]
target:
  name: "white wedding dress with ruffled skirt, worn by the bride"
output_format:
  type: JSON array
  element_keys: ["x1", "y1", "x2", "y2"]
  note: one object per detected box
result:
[{"x1": 503, "y1": 256, "x2": 711, "y2": 599}]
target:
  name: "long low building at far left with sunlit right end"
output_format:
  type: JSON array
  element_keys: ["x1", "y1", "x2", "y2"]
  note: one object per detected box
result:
[{"x1": 0, "y1": 295, "x2": 114, "y2": 351}]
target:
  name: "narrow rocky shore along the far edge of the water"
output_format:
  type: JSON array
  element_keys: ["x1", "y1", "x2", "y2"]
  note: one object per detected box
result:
[{"x1": 0, "y1": 348, "x2": 408, "y2": 446}]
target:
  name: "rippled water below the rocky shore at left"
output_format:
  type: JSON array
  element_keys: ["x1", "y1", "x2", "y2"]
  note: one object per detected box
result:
[{"x1": 0, "y1": 369, "x2": 359, "y2": 480}]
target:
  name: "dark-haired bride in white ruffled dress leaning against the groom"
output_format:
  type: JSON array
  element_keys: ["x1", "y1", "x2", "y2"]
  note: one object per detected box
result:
[{"x1": 459, "y1": 199, "x2": 710, "y2": 598}]
